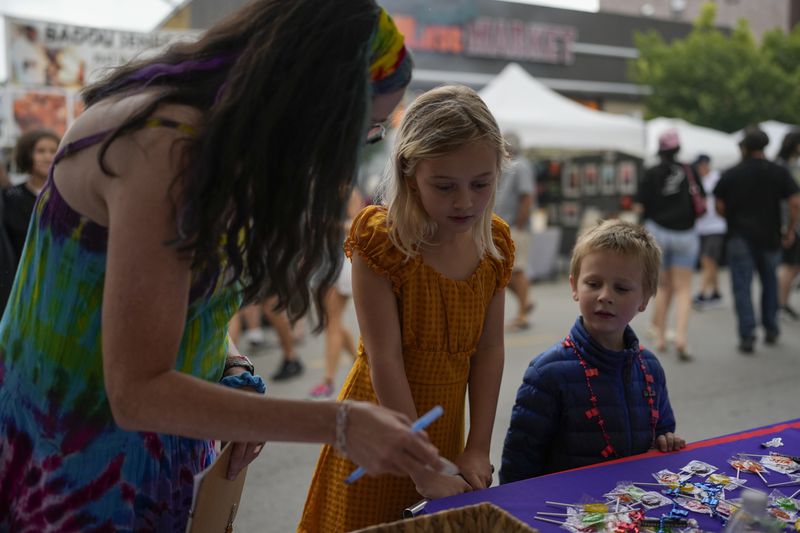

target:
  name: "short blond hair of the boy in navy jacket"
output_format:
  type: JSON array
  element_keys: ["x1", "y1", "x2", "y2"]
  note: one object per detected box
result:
[{"x1": 569, "y1": 219, "x2": 661, "y2": 298}]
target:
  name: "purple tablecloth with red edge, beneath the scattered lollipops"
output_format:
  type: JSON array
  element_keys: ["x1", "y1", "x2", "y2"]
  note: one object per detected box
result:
[{"x1": 424, "y1": 419, "x2": 800, "y2": 532}]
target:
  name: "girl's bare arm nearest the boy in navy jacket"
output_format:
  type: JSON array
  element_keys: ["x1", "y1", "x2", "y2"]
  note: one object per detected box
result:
[{"x1": 457, "y1": 290, "x2": 505, "y2": 489}]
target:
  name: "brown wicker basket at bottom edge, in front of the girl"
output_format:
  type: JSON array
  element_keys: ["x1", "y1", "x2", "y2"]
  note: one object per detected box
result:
[{"x1": 354, "y1": 502, "x2": 537, "y2": 533}]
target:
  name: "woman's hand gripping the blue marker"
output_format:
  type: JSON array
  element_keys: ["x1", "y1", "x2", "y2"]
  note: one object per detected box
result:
[{"x1": 346, "y1": 402, "x2": 442, "y2": 476}]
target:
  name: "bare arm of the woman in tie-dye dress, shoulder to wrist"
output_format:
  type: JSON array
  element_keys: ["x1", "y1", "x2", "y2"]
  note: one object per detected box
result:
[{"x1": 102, "y1": 124, "x2": 332, "y2": 442}]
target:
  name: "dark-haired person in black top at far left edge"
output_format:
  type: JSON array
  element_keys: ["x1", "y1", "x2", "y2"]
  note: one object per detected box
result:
[{"x1": 3, "y1": 130, "x2": 61, "y2": 262}]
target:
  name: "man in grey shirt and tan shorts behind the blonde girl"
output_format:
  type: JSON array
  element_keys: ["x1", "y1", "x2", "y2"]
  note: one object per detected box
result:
[{"x1": 495, "y1": 133, "x2": 536, "y2": 331}]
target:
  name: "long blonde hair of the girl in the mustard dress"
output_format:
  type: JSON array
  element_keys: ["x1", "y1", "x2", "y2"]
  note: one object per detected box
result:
[{"x1": 382, "y1": 85, "x2": 508, "y2": 259}]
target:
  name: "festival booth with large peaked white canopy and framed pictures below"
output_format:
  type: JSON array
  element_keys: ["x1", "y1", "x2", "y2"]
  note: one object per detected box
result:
[{"x1": 480, "y1": 63, "x2": 645, "y2": 279}]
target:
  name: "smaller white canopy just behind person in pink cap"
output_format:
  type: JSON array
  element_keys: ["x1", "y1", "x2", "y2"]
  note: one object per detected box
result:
[{"x1": 645, "y1": 118, "x2": 741, "y2": 169}]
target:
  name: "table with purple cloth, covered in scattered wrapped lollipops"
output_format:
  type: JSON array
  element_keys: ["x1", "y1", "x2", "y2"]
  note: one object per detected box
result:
[{"x1": 416, "y1": 419, "x2": 800, "y2": 533}]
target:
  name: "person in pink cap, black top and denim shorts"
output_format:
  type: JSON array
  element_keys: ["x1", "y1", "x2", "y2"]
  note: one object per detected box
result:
[{"x1": 637, "y1": 129, "x2": 705, "y2": 361}]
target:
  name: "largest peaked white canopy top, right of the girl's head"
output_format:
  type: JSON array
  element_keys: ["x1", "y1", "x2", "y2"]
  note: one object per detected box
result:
[{"x1": 480, "y1": 63, "x2": 644, "y2": 157}]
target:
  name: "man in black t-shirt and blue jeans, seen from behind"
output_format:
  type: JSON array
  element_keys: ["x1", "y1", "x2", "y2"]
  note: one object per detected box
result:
[{"x1": 714, "y1": 128, "x2": 800, "y2": 354}]
